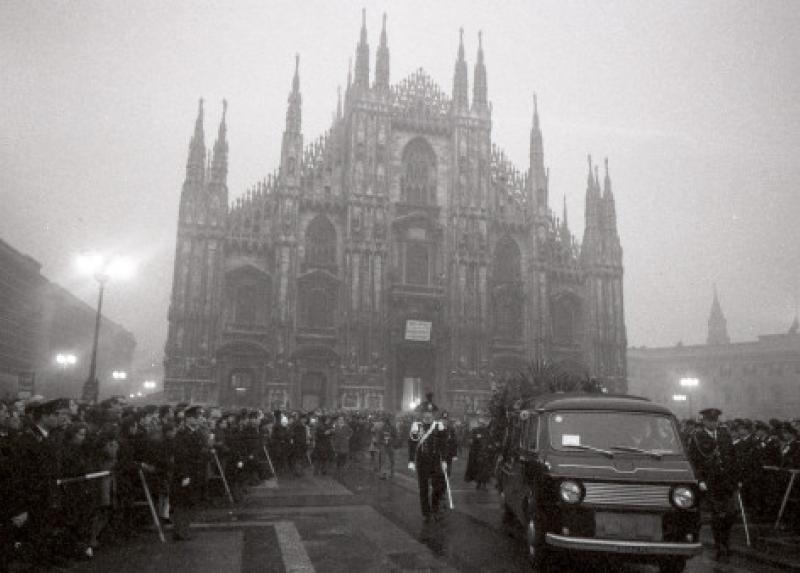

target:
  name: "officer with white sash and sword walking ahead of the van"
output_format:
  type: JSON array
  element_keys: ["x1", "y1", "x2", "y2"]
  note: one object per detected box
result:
[{"x1": 408, "y1": 400, "x2": 447, "y2": 523}]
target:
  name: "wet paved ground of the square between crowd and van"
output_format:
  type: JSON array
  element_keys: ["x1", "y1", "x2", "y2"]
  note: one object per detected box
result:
[{"x1": 61, "y1": 451, "x2": 785, "y2": 573}]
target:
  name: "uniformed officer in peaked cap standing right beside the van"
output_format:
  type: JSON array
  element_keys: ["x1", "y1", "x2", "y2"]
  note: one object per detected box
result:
[{"x1": 688, "y1": 408, "x2": 739, "y2": 562}]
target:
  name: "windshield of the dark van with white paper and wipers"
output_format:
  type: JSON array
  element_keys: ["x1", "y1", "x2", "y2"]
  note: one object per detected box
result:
[{"x1": 549, "y1": 411, "x2": 681, "y2": 456}]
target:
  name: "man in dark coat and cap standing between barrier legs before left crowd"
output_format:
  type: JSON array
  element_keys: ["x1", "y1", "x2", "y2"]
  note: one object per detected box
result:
[{"x1": 170, "y1": 406, "x2": 208, "y2": 541}]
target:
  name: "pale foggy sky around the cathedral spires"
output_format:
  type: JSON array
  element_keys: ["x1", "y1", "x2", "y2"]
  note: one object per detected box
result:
[{"x1": 0, "y1": 0, "x2": 800, "y2": 376}]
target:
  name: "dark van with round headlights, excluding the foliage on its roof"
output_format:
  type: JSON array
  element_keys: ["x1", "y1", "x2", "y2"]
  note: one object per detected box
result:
[{"x1": 497, "y1": 394, "x2": 702, "y2": 572}]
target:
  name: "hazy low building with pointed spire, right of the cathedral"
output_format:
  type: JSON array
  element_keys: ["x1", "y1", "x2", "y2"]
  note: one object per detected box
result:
[{"x1": 628, "y1": 289, "x2": 800, "y2": 419}]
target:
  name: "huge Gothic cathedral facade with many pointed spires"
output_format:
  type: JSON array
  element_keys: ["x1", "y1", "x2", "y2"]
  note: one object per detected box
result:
[{"x1": 165, "y1": 12, "x2": 626, "y2": 412}]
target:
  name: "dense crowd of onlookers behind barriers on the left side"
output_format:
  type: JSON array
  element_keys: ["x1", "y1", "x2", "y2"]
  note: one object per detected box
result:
[{"x1": 0, "y1": 398, "x2": 476, "y2": 572}]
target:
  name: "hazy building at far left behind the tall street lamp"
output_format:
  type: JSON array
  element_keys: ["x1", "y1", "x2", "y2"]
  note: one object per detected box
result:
[{"x1": 0, "y1": 235, "x2": 136, "y2": 398}]
